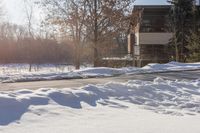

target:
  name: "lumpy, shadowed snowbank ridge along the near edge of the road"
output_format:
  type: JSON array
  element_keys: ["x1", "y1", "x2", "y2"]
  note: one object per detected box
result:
[{"x1": 0, "y1": 78, "x2": 200, "y2": 126}]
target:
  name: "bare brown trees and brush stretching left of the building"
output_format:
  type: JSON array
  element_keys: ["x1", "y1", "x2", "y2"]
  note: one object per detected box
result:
[{"x1": 0, "y1": 0, "x2": 131, "y2": 69}]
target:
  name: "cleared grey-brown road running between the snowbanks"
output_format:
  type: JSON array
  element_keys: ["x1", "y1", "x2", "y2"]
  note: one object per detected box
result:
[{"x1": 0, "y1": 70, "x2": 200, "y2": 91}]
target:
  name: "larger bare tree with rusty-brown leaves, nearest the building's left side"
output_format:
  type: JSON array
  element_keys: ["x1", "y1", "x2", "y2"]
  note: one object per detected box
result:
[{"x1": 83, "y1": 0, "x2": 134, "y2": 66}]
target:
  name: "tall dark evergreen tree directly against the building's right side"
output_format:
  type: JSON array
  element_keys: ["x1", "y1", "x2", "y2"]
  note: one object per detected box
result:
[{"x1": 168, "y1": 0, "x2": 195, "y2": 62}]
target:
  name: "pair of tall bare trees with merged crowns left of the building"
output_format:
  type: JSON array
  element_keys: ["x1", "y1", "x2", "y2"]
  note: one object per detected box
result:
[{"x1": 39, "y1": 0, "x2": 134, "y2": 69}]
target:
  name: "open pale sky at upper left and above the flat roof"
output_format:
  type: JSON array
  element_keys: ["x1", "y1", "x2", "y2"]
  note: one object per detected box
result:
[{"x1": 1, "y1": 0, "x2": 198, "y2": 24}]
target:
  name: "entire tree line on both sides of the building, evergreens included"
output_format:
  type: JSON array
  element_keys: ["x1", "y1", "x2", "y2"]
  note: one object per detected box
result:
[{"x1": 0, "y1": 0, "x2": 200, "y2": 69}]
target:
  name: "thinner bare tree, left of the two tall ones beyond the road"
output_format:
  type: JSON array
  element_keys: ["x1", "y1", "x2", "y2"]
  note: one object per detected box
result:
[{"x1": 42, "y1": 0, "x2": 86, "y2": 69}]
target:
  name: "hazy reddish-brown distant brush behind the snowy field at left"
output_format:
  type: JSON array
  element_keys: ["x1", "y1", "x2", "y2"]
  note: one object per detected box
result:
[{"x1": 0, "y1": 23, "x2": 74, "y2": 64}]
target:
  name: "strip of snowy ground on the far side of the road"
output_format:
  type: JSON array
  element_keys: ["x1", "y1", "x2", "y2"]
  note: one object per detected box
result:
[{"x1": 0, "y1": 62, "x2": 200, "y2": 82}]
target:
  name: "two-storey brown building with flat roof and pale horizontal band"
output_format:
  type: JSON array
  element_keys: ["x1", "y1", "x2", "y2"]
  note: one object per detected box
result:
[{"x1": 128, "y1": 5, "x2": 172, "y2": 67}]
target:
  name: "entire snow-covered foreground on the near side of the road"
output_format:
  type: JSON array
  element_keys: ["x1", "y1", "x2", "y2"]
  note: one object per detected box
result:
[{"x1": 0, "y1": 78, "x2": 200, "y2": 133}]
